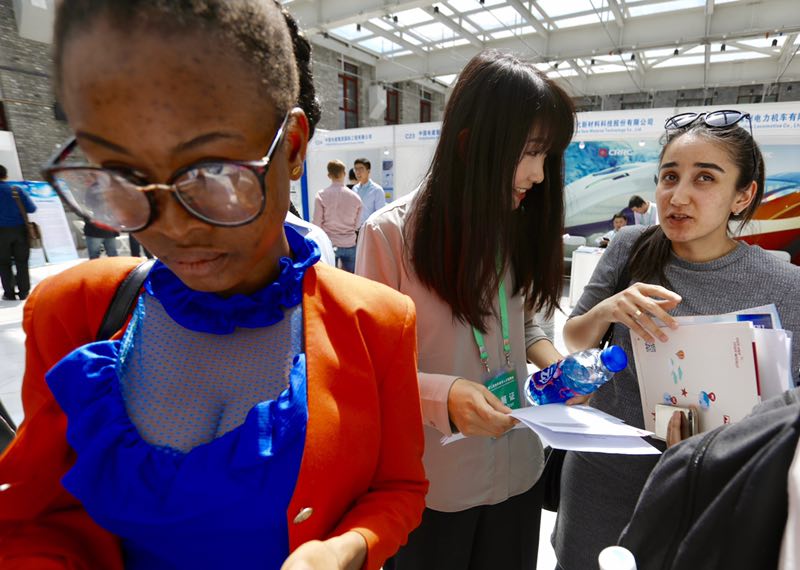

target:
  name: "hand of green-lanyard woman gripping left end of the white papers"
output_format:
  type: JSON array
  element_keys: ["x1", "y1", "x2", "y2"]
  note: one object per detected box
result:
[{"x1": 447, "y1": 378, "x2": 517, "y2": 437}]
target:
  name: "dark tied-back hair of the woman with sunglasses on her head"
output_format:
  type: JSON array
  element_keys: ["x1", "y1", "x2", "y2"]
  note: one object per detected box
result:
[{"x1": 629, "y1": 121, "x2": 764, "y2": 287}]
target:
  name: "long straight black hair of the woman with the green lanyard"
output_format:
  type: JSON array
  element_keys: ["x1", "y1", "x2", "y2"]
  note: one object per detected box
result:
[{"x1": 404, "y1": 51, "x2": 575, "y2": 331}]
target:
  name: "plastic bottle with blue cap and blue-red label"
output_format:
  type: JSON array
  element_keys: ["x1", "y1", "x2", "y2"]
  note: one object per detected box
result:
[{"x1": 525, "y1": 345, "x2": 628, "y2": 405}]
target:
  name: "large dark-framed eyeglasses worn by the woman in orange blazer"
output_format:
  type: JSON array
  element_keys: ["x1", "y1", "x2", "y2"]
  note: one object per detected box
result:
[{"x1": 42, "y1": 114, "x2": 289, "y2": 232}]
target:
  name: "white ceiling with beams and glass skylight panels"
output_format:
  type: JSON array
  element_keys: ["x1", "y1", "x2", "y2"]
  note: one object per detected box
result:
[{"x1": 284, "y1": 0, "x2": 800, "y2": 96}]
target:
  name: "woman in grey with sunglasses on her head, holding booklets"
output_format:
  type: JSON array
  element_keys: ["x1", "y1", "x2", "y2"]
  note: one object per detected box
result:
[{"x1": 553, "y1": 111, "x2": 800, "y2": 570}]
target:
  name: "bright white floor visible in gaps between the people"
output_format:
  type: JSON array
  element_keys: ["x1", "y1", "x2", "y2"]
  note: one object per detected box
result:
[{"x1": 0, "y1": 260, "x2": 569, "y2": 570}]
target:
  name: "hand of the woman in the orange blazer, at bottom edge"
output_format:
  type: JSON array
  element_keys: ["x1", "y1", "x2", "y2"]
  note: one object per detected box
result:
[{"x1": 281, "y1": 531, "x2": 367, "y2": 570}]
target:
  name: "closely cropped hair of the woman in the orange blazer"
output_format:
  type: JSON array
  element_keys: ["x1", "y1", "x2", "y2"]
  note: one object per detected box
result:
[{"x1": 53, "y1": 0, "x2": 320, "y2": 136}]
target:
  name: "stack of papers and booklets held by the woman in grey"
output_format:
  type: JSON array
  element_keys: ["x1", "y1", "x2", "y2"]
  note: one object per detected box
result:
[{"x1": 631, "y1": 305, "x2": 791, "y2": 432}]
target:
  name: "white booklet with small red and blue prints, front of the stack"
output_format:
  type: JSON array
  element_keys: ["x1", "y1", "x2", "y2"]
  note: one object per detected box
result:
[{"x1": 631, "y1": 321, "x2": 760, "y2": 432}]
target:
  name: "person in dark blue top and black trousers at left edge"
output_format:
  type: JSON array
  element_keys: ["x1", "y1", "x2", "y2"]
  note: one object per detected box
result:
[{"x1": 0, "y1": 164, "x2": 36, "y2": 301}]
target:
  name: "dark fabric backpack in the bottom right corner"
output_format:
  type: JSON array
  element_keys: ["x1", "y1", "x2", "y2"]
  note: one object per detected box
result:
[{"x1": 619, "y1": 388, "x2": 800, "y2": 570}]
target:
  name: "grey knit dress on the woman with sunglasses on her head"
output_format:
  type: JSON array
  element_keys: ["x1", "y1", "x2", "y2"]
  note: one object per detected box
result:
[{"x1": 553, "y1": 227, "x2": 800, "y2": 570}]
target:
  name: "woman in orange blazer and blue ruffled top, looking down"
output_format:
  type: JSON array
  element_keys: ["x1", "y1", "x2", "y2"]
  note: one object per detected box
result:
[{"x1": 0, "y1": 0, "x2": 427, "y2": 570}]
